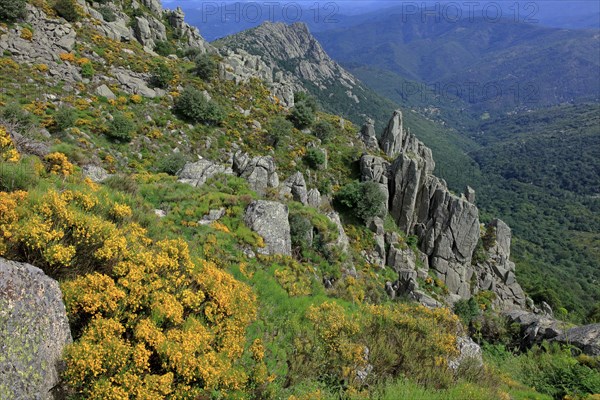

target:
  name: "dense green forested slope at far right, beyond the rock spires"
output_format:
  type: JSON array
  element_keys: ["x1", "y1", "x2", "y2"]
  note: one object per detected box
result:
[{"x1": 472, "y1": 104, "x2": 600, "y2": 320}]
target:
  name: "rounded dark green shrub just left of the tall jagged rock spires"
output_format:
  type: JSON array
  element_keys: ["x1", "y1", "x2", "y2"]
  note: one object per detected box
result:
[{"x1": 335, "y1": 181, "x2": 386, "y2": 221}]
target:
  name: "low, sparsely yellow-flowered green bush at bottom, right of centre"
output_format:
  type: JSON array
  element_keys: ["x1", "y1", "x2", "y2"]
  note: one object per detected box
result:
[{"x1": 288, "y1": 301, "x2": 461, "y2": 394}]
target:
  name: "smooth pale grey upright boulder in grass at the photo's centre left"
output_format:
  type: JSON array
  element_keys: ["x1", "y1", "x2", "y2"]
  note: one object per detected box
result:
[{"x1": 244, "y1": 200, "x2": 292, "y2": 256}]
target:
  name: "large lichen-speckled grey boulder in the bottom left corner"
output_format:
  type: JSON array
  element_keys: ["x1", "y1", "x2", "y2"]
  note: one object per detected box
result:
[{"x1": 0, "y1": 258, "x2": 72, "y2": 399}]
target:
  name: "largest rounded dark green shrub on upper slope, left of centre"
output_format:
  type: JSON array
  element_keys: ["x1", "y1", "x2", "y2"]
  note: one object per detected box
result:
[{"x1": 174, "y1": 87, "x2": 225, "y2": 125}]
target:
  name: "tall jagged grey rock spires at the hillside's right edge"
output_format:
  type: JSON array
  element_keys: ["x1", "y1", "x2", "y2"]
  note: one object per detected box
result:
[{"x1": 360, "y1": 110, "x2": 527, "y2": 308}]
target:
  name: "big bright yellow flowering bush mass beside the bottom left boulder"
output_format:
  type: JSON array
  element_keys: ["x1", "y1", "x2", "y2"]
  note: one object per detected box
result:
[{"x1": 0, "y1": 184, "x2": 258, "y2": 399}]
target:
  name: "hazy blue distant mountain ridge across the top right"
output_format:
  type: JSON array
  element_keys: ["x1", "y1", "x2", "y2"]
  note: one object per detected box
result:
[{"x1": 315, "y1": 13, "x2": 600, "y2": 111}]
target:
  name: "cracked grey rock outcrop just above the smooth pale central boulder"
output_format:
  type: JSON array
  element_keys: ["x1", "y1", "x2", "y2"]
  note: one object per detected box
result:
[{"x1": 233, "y1": 151, "x2": 279, "y2": 196}]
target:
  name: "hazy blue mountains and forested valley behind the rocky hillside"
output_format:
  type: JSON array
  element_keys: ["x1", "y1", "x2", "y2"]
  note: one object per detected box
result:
[{"x1": 192, "y1": 1, "x2": 600, "y2": 320}]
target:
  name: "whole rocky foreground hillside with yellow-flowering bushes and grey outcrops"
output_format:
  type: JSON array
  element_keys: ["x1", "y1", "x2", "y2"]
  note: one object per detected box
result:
[{"x1": 0, "y1": 0, "x2": 600, "y2": 400}]
